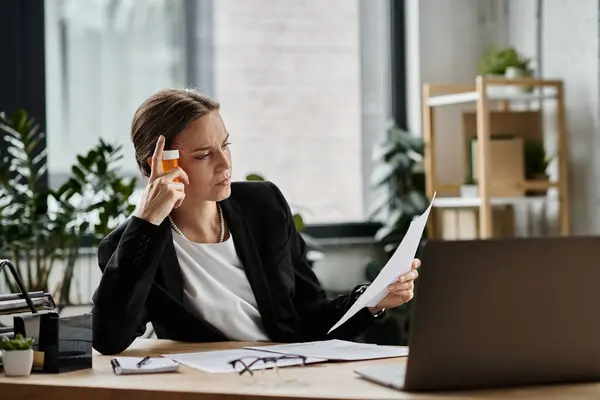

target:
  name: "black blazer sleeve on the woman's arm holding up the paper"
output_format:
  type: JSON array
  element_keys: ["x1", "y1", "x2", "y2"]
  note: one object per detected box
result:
[{"x1": 270, "y1": 183, "x2": 375, "y2": 340}]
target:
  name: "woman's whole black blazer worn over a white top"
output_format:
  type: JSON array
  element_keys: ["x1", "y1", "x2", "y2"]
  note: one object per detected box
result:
[{"x1": 92, "y1": 182, "x2": 374, "y2": 354}]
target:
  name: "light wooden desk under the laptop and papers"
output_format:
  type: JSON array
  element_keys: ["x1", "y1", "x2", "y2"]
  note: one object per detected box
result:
[{"x1": 0, "y1": 339, "x2": 600, "y2": 400}]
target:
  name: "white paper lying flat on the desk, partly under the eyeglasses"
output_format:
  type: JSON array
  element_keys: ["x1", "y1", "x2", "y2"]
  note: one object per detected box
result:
[{"x1": 163, "y1": 347, "x2": 326, "y2": 374}]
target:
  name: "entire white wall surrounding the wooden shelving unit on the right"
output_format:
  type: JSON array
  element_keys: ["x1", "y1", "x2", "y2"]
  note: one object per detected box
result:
[{"x1": 406, "y1": 0, "x2": 600, "y2": 233}]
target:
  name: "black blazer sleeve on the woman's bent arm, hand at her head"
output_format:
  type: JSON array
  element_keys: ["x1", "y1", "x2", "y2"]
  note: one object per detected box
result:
[{"x1": 92, "y1": 217, "x2": 167, "y2": 354}]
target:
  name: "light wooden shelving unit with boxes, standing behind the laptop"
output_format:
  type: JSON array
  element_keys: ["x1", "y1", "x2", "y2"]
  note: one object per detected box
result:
[{"x1": 422, "y1": 76, "x2": 571, "y2": 239}]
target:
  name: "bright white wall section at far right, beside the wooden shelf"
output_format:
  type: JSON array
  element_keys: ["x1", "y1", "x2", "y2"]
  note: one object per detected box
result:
[{"x1": 508, "y1": 0, "x2": 600, "y2": 234}]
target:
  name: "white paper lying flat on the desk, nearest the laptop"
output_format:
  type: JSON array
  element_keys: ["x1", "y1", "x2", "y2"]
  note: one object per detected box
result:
[{"x1": 247, "y1": 339, "x2": 408, "y2": 361}]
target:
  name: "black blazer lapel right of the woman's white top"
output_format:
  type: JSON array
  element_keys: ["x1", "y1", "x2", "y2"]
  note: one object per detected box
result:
[{"x1": 220, "y1": 198, "x2": 276, "y2": 337}]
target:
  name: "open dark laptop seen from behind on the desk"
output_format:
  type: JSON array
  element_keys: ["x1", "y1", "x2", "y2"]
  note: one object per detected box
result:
[{"x1": 355, "y1": 237, "x2": 600, "y2": 391}]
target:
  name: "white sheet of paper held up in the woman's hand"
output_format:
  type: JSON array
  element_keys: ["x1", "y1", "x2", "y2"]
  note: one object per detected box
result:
[{"x1": 327, "y1": 193, "x2": 435, "y2": 333}]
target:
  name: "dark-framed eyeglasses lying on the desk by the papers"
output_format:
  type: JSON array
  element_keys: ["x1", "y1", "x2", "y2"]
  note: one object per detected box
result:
[{"x1": 229, "y1": 354, "x2": 306, "y2": 383}]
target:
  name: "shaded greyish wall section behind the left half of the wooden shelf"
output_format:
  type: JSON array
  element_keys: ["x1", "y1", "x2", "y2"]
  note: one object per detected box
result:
[{"x1": 406, "y1": 0, "x2": 506, "y2": 183}]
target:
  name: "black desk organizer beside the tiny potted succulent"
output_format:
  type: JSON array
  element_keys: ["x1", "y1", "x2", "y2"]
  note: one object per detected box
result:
[{"x1": 0, "y1": 260, "x2": 92, "y2": 373}]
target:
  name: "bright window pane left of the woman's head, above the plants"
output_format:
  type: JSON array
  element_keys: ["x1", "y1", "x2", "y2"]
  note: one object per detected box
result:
[{"x1": 45, "y1": 0, "x2": 186, "y2": 185}]
